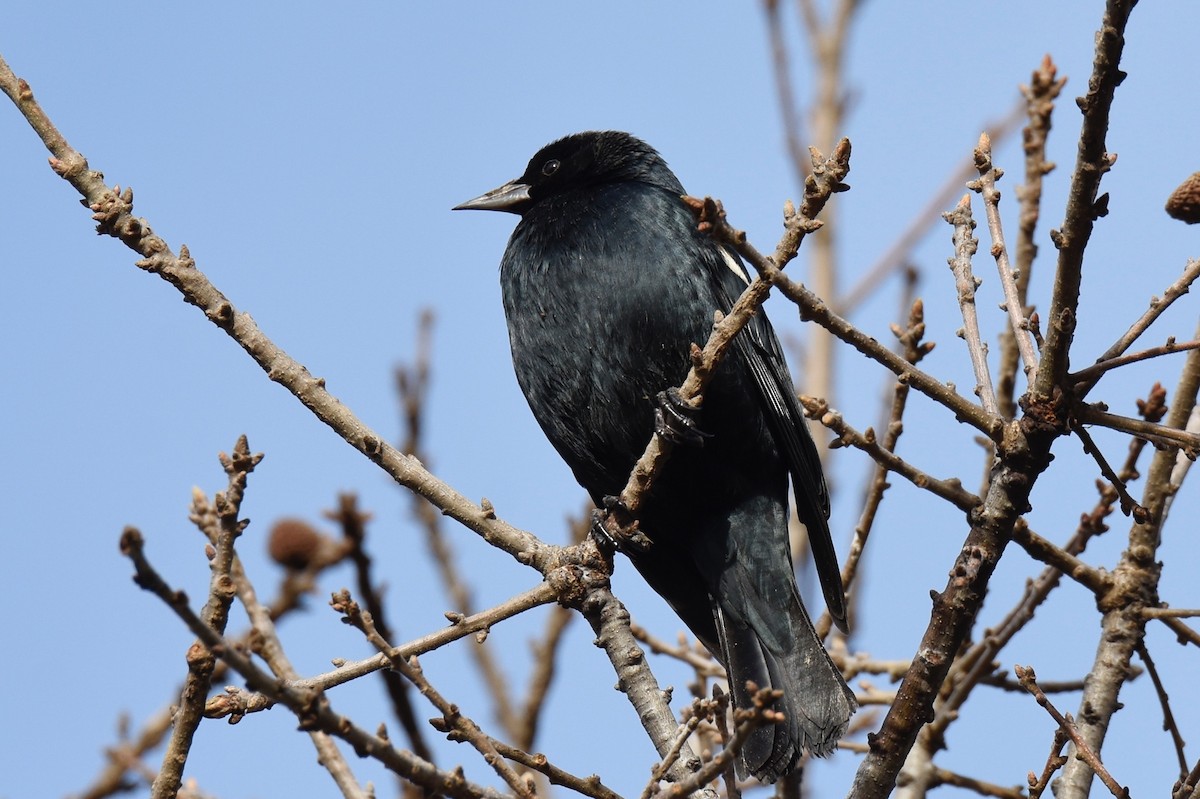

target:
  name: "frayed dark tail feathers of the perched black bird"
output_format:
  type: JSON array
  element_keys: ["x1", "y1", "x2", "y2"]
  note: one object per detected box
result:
[{"x1": 714, "y1": 563, "x2": 858, "y2": 782}]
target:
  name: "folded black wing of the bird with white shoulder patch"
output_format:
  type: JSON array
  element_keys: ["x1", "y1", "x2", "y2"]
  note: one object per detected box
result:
[{"x1": 706, "y1": 245, "x2": 847, "y2": 631}]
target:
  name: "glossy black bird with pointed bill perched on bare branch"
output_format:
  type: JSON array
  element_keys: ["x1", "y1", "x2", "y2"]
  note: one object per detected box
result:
[{"x1": 456, "y1": 132, "x2": 857, "y2": 782}]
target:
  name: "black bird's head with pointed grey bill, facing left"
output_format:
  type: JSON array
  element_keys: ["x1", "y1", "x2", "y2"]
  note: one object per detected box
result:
[{"x1": 454, "y1": 131, "x2": 684, "y2": 215}]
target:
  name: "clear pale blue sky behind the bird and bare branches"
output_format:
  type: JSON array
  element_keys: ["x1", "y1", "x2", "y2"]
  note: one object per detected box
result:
[{"x1": 0, "y1": 0, "x2": 1200, "y2": 799}]
